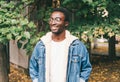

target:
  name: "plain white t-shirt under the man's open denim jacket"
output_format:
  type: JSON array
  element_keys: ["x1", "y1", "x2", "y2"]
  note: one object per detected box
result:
[{"x1": 50, "y1": 40, "x2": 68, "y2": 82}]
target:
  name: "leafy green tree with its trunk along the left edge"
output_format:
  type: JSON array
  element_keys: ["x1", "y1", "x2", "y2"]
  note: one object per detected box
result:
[{"x1": 0, "y1": 0, "x2": 37, "y2": 82}]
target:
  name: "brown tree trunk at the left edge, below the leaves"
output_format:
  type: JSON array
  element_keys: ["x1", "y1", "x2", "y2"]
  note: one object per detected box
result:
[{"x1": 0, "y1": 44, "x2": 9, "y2": 82}]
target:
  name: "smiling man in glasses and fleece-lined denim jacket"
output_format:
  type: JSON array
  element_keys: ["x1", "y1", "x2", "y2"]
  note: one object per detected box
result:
[{"x1": 29, "y1": 8, "x2": 92, "y2": 82}]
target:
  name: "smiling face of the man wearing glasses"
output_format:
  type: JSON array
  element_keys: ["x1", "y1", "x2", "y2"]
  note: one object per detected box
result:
[{"x1": 49, "y1": 11, "x2": 68, "y2": 34}]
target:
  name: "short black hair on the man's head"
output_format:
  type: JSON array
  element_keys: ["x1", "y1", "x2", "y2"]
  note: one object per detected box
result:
[{"x1": 52, "y1": 7, "x2": 70, "y2": 22}]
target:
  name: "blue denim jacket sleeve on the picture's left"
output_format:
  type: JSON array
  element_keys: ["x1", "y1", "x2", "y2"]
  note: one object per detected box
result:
[{"x1": 29, "y1": 43, "x2": 39, "y2": 82}]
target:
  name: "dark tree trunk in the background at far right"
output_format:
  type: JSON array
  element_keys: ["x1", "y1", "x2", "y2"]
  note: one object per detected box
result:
[{"x1": 108, "y1": 36, "x2": 116, "y2": 58}]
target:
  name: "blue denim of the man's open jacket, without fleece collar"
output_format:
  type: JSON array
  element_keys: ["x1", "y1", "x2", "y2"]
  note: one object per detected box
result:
[{"x1": 29, "y1": 40, "x2": 92, "y2": 82}]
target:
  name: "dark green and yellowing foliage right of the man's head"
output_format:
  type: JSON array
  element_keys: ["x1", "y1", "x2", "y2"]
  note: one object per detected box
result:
[{"x1": 62, "y1": 0, "x2": 120, "y2": 42}]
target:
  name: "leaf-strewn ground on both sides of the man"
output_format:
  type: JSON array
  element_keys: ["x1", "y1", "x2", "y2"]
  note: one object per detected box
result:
[{"x1": 9, "y1": 44, "x2": 120, "y2": 82}]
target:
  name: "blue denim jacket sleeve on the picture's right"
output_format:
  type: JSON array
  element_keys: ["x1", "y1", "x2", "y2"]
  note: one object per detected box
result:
[{"x1": 80, "y1": 45, "x2": 92, "y2": 82}]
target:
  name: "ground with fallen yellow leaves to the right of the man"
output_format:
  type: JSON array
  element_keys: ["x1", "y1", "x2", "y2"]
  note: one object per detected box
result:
[{"x1": 89, "y1": 56, "x2": 120, "y2": 82}]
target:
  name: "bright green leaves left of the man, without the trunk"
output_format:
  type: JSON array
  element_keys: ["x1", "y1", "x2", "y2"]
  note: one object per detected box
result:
[{"x1": 0, "y1": 0, "x2": 40, "y2": 52}]
